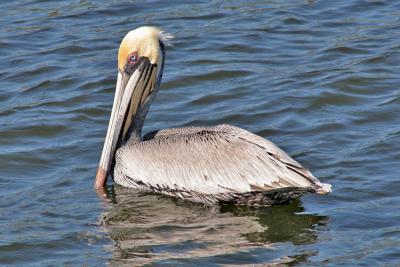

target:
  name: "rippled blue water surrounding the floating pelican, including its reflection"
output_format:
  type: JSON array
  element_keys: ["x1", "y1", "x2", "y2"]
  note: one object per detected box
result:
[{"x1": 0, "y1": 0, "x2": 400, "y2": 266}]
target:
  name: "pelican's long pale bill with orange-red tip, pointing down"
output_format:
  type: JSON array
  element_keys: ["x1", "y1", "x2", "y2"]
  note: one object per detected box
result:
[{"x1": 94, "y1": 60, "x2": 155, "y2": 189}]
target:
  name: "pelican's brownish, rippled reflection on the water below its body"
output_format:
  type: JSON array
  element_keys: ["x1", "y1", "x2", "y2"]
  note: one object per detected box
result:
[{"x1": 101, "y1": 185, "x2": 328, "y2": 265}]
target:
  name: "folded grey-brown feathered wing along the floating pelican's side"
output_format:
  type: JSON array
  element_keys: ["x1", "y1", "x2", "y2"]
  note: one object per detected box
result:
[{"x1": 114, "y1": 125, "x2": 329, "y2": 203}]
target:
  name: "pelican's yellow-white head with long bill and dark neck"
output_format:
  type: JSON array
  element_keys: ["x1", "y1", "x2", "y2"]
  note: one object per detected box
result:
[{"x1": 94, "y1": 27, "x2": 169, "y2": 188}]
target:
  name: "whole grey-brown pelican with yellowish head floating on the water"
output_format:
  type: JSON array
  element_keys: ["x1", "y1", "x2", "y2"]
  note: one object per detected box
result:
[{"x1": 94, "y1": 27, "x2": 331, "y2": 205}]
